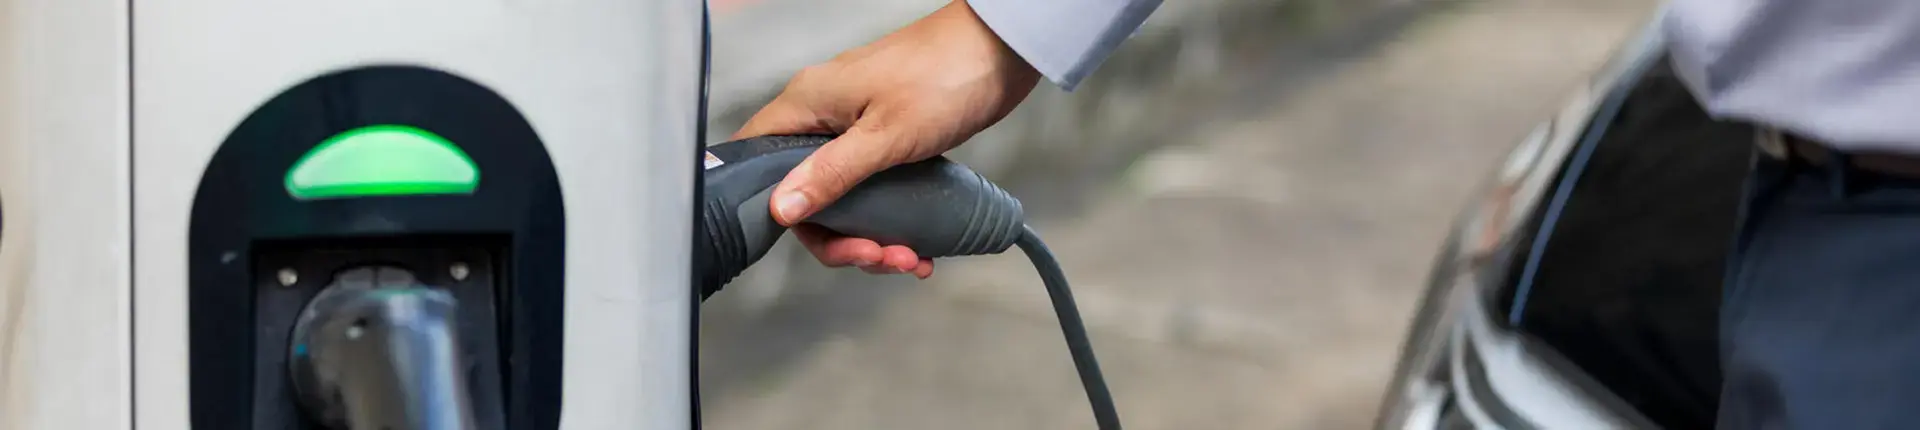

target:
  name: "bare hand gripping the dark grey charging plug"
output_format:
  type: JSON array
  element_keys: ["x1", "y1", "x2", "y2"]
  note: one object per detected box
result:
[{"x1": 733, "y1": 0, "x2": 1041, "y2": 278}]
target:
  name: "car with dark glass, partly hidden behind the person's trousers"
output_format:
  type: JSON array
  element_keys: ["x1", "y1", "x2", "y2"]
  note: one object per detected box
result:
[{"x1": 1377, "y1": 11, "x2": 1755, "y2": 428}]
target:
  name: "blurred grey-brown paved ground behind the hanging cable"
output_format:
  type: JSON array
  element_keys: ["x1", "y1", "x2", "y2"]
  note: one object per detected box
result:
[{"x1": 703, "y1": 0, "x2": 1647, "y2": 430}]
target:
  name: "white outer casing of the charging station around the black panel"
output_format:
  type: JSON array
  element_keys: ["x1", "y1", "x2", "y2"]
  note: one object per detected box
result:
[{"x1": 0, "y1": 0, "x2": 705, "y2": 430}]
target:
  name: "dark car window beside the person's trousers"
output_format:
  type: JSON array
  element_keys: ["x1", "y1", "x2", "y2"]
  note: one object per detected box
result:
[{"x1": 1496, "y1": 55, "x2": 1753, "y2": 428}]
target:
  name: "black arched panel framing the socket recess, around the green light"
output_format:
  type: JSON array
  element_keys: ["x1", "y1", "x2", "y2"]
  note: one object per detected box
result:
[{"x1": 183, "y1": 65, "x2": 566, "y2": 430}]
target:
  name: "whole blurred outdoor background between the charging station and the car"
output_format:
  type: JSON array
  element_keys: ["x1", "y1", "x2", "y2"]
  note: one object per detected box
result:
[{"x1": 701, "y1": 0, "x2": 1655, "y2": 430}]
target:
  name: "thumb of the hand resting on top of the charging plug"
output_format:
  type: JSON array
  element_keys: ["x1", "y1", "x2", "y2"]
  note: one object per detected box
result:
[{"x1": 772, "y1": 127, "x2": 908, "y2": 227}]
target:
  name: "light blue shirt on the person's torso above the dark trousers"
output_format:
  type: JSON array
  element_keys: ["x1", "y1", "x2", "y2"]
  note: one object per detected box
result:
[{"x1": 1661, "y1": 0, "x2": 1920, "y2": 154}]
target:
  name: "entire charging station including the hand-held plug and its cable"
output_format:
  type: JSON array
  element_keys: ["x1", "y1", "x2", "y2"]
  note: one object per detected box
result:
[{"x1": 0, "y1": 0, "x2": 1119, "y2": 430}]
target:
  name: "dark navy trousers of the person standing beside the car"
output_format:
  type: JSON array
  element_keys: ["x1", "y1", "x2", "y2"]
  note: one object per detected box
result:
[{"x1": 1718, "y1": 143, "x2": 1920, "y2": 430}]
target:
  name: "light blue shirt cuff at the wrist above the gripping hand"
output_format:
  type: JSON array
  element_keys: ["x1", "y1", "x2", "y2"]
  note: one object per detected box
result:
[{"x1": 968, "y1": 0, "x2": 1162, "y2": 90}]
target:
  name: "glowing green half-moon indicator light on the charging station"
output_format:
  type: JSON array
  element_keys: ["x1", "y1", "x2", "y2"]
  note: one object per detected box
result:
[{"x1": 286, "y1": 125, "x2": 480, "y2": 200}]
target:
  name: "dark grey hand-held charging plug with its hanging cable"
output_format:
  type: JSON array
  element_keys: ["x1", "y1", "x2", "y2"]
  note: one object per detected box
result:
[{"x1": 695, "y1": 136, "x2": 1119, "y2": 430}]
